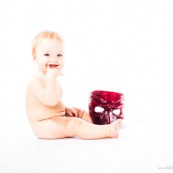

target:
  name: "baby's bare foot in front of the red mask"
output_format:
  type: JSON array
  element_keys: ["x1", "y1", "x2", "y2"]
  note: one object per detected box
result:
[{"x1": 108, "y1": 119, "x2": 122, "y2": 138}]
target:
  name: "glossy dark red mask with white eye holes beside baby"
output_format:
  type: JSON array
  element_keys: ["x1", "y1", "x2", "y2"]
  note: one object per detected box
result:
[{"x1": 89, "y1": 90, "x2": 124, "y2": 125}]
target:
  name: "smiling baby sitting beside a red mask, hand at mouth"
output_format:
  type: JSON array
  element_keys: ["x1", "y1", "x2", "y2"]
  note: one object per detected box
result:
[{"x1": 26, "y1": 31, "x2": 121, "y2": 139}]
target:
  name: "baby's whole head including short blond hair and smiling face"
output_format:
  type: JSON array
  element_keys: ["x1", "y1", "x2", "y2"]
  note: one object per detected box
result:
[{"x1": 32, "y1": 31, "x2": 64, "y2": 73}]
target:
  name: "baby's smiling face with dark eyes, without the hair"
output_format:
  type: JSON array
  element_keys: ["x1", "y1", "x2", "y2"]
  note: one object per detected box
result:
[{"x1": 34, "y1": 38, "x2": 64, "y2": 73}]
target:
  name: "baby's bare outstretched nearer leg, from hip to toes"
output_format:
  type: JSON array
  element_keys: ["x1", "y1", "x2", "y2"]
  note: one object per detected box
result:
[{"x1": 33, "y1": 117, "x2": 121, "y2": 139}]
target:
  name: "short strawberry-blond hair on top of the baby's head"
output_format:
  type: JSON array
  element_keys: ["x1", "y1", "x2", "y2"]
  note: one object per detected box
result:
[{"x1": 32, "y1": 31, "x2": 63, "y2": 56}]
